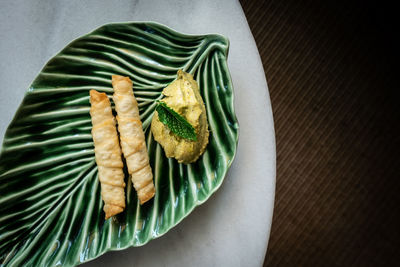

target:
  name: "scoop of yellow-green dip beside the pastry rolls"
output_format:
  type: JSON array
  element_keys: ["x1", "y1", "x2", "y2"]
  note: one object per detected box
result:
[{"x1": 151, "y1": 70, "x2": 209, "y2": 164}]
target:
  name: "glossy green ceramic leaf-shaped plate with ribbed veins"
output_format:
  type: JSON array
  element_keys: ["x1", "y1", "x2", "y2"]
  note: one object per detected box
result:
[{"x1": 0, "y1": 22, "x2": 238, "y2": 266}]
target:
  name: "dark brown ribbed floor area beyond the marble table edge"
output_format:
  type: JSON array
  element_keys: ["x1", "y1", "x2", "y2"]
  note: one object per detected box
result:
[{"x1": 240, "y1": 0, "x2": 400, "y2": 266}]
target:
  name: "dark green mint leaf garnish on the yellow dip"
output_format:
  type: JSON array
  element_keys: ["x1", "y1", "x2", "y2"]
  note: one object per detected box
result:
[{"x1": 156, "y1": 101, "x2": 197, "y2": 141}]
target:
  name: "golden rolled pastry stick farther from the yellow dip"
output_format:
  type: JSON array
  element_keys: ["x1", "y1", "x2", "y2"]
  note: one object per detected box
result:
[{"x1": 90, "y1": 90, "x2": 125, "y2": 220}]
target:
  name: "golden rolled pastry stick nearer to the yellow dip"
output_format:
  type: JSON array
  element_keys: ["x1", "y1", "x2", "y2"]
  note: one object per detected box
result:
[{"x1": 112, "y1": 75, "x2": 155, "y2": 204}]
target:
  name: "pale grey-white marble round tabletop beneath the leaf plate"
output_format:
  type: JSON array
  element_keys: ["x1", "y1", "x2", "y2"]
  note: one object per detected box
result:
[{"x1": 0, "y1": 0, "x2": 275, "y2": 266}]
